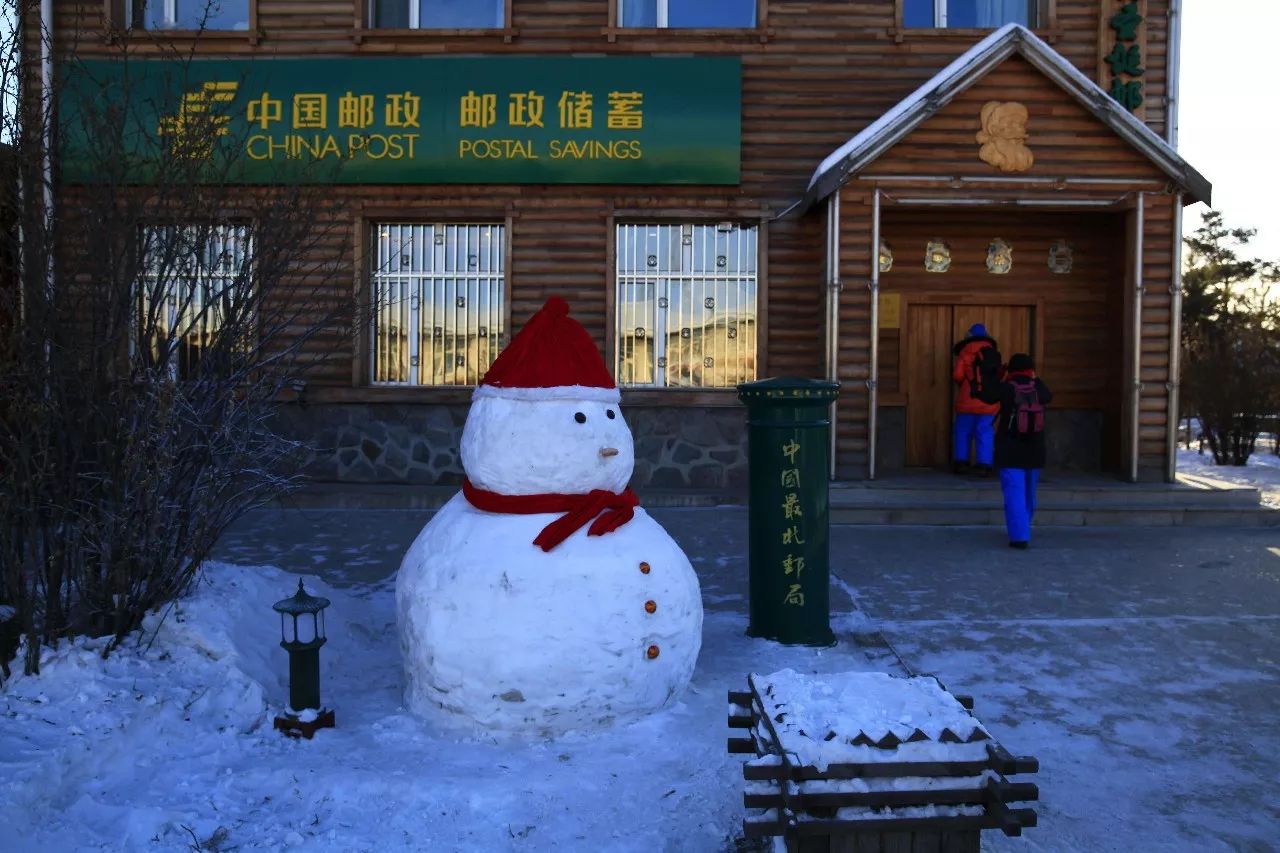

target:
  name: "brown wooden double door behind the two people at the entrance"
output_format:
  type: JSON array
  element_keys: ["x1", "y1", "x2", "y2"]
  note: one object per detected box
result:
[{"x1": 902, "y1": 305, "x2": 1034, "y2": 467}]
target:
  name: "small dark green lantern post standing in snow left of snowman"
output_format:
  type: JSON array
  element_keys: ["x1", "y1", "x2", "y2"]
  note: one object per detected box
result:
[{"x1": 271, "y1": 579, "x2": 335, "y2": 739}]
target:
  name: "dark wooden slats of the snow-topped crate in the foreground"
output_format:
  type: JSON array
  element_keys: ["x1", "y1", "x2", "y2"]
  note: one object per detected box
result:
[{"x1": 728, "y1": 676, "x2": 1039, "y2": 853}]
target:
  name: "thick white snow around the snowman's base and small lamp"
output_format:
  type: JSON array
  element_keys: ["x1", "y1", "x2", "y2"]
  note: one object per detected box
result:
[{"x1": 0, "y1": 564, "x2": 867, "y2": 853}]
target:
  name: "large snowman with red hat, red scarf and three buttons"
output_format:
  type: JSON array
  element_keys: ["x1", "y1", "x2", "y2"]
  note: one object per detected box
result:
[{"x1": 396, "y1": 297, "x2": 703, "y2": 735}]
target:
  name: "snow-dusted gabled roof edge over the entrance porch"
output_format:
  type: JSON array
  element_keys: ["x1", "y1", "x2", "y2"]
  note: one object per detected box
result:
[{"x1": 792, "y1": 23, "x2": 1212, "y2": 213}]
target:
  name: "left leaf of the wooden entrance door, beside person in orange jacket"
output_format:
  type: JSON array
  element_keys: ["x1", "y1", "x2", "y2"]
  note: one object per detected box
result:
[{"x1": 902, "y1": 305, "x2": 955, "y2": 467}]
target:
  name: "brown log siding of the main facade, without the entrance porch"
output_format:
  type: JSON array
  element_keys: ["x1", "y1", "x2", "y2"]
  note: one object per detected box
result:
[{"x1": 47, "y1": 0, "x2": 1165, "y2": 405}]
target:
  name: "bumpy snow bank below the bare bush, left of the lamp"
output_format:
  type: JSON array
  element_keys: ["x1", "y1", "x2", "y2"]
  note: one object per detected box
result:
[{"x1": 0, "y1": 560, "x2": 289, "y2": 849}]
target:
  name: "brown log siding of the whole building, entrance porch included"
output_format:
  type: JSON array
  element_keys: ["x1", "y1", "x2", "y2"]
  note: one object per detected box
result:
[{"x1": 52, "y1": 0, "x2": 1192, "y2": 478}]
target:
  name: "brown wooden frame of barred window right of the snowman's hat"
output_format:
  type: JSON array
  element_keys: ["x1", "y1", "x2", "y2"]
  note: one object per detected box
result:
[{"x1": 604, "y1": 217, "x2": 769, "y2": 394}]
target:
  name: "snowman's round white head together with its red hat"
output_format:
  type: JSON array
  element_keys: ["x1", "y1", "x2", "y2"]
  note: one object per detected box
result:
[{"x1": 462, "y1": 296, "x2": 635, "y2": 494}]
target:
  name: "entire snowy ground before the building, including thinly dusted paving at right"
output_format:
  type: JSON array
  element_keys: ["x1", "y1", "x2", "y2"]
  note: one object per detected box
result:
[{"x1": 0, "y1": 507, "x2": 1280, "y2": 853}]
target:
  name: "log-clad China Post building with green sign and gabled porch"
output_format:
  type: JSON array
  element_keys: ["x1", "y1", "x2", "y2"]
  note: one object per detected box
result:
[{"x1": 52, "y1": 0, "x2": 1210, "y2": 491}]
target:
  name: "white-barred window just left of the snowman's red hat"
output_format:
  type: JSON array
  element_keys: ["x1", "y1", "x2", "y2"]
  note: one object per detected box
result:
[{"x1": 370, "y1": 223, "x2": 507, "y2": 386}]
